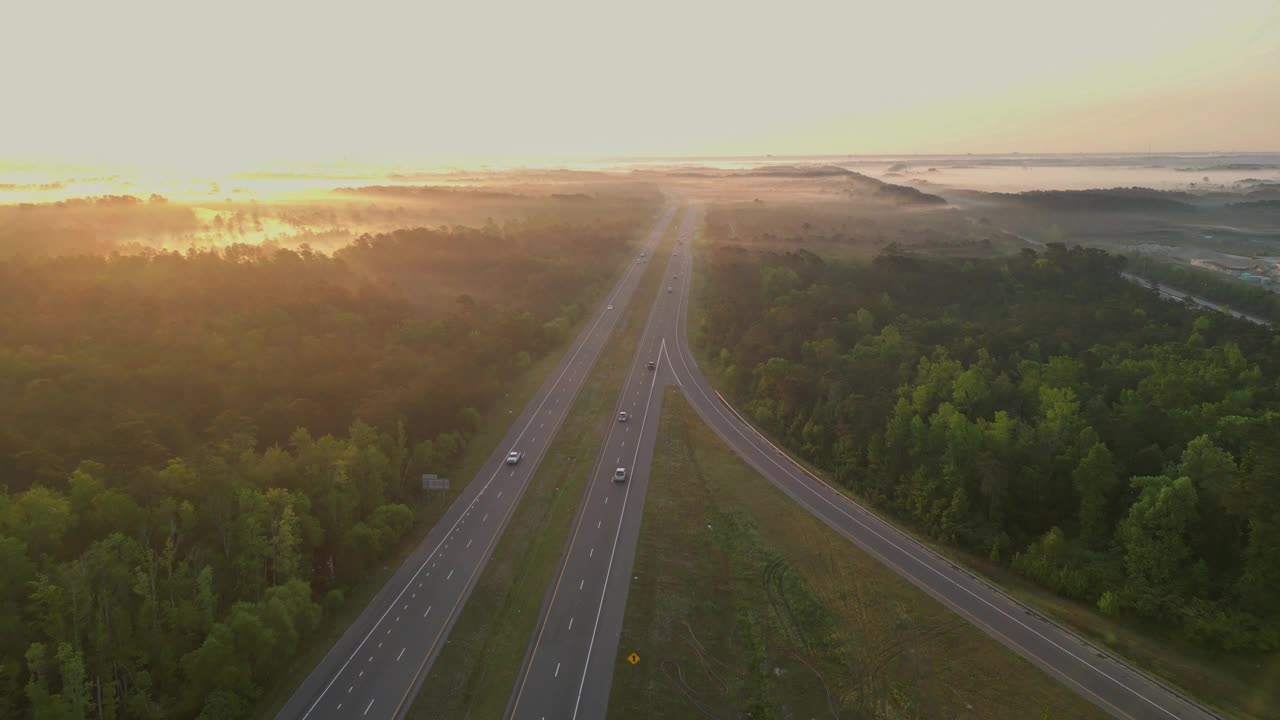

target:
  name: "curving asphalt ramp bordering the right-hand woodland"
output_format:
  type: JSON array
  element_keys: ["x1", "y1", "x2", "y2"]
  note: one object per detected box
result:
[{"x1": 660, "y1": 211, "x2": 1216, "y2": 720}]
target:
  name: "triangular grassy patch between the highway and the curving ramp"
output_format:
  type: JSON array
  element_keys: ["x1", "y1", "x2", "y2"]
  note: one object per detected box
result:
[{"x1": 609, "y1": 389, "x2": 1106, "y2": 720}]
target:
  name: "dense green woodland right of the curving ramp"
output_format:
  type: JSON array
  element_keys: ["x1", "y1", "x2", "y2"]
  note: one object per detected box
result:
[{"x1": 695, "y1": 245, "x2": 1280, "y2": 652}]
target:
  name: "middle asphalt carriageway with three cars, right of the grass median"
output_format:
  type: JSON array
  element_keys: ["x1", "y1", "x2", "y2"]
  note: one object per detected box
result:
[{"x1": 507, "y1": 203, "x2": 698, "y2": 720}]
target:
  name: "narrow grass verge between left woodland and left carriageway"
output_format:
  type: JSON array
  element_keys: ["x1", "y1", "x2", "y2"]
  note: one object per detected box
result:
[{"x1": 247, "y1": 208, "x2": 658, "y2": 720}]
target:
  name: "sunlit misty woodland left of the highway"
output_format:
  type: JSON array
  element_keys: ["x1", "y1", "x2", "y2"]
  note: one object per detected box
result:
[{"x1": 0, "y1": 202, "x2": 652, "y2": 720}]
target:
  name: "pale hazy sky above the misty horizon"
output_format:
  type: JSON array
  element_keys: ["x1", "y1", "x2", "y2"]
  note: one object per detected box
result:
[{"x1": 0, "y1": 0, "x2": 1280, "y2": 172}]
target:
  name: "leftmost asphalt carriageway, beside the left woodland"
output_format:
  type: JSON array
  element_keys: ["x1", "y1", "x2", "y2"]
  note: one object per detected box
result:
[{"x1": 278, "y1": 206, "x2": 676, "y2": 720}]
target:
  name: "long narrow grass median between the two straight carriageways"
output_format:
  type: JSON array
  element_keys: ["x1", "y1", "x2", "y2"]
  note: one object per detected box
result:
[{"x1": 408, "y1": 204, "x2": 678, "y2": 720}]
